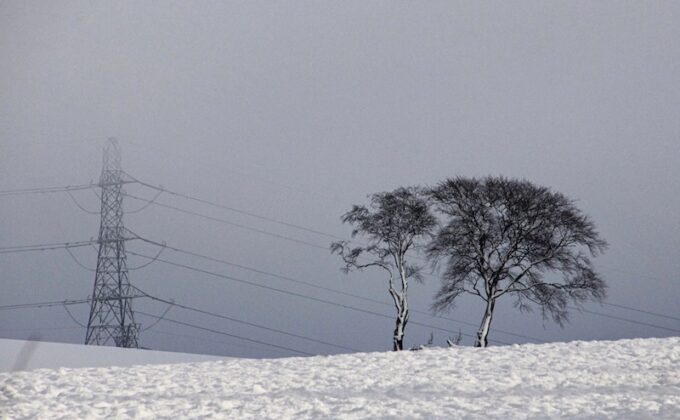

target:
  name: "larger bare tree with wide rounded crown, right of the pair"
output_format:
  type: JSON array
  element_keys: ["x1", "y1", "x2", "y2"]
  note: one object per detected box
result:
[{"x1": 428, "y1": 177, "x2": 607, "y2": 347}]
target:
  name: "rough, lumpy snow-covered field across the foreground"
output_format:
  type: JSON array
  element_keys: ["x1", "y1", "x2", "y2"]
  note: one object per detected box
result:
[{"x1": 0, "y1": 338, "x2": 680, "y2": 419}]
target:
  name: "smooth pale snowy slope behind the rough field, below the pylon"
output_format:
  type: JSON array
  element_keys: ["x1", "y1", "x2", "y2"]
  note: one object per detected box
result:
[{"x1": 0, "y1": 338, "x2": 222, "y2": 372}]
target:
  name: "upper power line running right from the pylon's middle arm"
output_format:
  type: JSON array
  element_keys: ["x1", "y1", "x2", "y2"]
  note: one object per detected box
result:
[{"x1": 128, "y1": 230, "x2": 543, "y2": 342}]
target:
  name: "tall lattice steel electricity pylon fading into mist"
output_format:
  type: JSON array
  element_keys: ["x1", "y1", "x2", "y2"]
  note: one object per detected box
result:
[{"x1": 85, "y1": 138, "x2": 139, "y2": 348}]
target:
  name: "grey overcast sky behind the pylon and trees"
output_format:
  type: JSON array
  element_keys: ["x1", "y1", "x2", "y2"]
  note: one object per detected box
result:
[{"x1": 0, "y1": 1, "x2": 680, "y2": 357}]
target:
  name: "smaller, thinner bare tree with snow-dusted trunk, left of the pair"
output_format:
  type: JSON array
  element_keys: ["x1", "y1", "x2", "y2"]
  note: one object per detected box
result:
[{"x1": 331, "y1": 187, "x2": 436, "y2": 351}]
